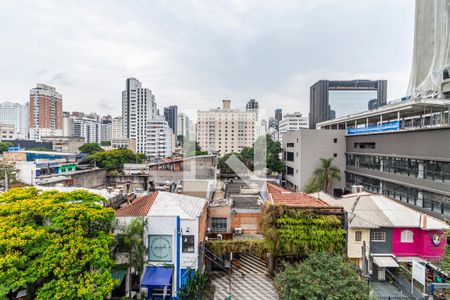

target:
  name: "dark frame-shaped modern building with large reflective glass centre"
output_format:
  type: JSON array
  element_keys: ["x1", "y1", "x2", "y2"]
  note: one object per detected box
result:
[{"x1": 309, "y1": 80, "x2": 387, "y2": 129}]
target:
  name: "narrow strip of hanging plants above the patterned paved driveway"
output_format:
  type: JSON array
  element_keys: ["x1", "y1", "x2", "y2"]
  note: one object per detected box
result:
[{"x1": 205, "y1": 239, "x2": 268, "y2": 256}]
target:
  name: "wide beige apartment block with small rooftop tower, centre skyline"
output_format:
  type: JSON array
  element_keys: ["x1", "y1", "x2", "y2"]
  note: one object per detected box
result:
[{"x1": 196, "y1": 100, "x2": 257, "y2": 155}]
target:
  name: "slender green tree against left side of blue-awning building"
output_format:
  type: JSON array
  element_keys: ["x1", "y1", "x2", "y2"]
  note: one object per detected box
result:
[{"x1": 118, "y1": 218, "x2": 147, "y2": 299}]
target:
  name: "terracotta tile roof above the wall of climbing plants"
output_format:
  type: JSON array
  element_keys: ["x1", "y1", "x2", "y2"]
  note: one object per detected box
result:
[{"x1": 267, "y1": 182, "x2": 330, "y2": 207}]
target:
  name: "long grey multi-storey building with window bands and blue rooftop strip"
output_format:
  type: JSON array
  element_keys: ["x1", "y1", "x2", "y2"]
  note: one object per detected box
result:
[{"x1": 318, "y1": 99, "x2": 450, "y2": 220}]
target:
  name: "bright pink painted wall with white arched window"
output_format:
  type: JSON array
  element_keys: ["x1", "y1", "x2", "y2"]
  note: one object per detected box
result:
[{"x1": 392, "y1": 228, "x2": 446, "y2": 259}]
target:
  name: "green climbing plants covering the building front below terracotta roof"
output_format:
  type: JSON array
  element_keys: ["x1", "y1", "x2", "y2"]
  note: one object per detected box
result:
[{"x1": 262, "y1": 205, "x2": 345, "y2": 257}]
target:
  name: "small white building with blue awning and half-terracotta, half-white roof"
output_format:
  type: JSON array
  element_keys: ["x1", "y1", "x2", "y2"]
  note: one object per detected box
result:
[{"x1": 116, "y1": 192, "x2": 207, "y2": 299}]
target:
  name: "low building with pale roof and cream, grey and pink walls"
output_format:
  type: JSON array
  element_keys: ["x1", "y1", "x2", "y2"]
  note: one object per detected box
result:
[{"x1": 313, "y1": 192, "x2": 450, "y2": 281}]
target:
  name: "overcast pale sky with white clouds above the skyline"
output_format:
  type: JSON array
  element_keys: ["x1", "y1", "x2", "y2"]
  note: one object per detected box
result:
[{"x1": 0, "y1": 0, "x2": 414, "y2": 116}]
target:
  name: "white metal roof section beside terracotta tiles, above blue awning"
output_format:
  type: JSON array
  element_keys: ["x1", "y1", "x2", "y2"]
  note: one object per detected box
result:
[{"x1": 147, "y1": 192, "x2": 207, "y2": 219}]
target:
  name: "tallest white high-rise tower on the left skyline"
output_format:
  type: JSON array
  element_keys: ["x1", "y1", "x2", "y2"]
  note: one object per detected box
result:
[{"x1": 122, "y1": 78, "x2": 156, "y2": 153}]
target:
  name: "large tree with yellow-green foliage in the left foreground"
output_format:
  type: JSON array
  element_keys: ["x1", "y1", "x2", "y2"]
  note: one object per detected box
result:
[{"x1": 0, "y1": 188, "x2": 116, "y2": 299}]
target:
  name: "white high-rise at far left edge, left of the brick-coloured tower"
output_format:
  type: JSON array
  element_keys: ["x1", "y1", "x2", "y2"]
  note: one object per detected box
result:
[{"x1": 0, "y1": 102, "x2": 29, "y2": 139}]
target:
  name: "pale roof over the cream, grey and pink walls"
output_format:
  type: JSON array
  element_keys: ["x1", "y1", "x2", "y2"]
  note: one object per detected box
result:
[{"x1": 323, "y1": 192, "x2": 450, "y2": 230}]
